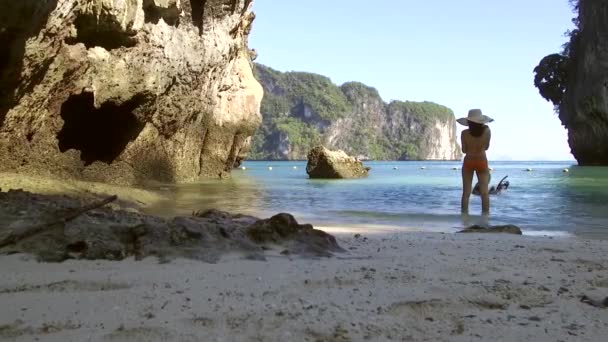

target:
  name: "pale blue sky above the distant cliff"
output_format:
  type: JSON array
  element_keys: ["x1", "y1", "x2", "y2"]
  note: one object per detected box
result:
[{"x1": 249, "y1": 0, "x2": 574, "y2": 160}]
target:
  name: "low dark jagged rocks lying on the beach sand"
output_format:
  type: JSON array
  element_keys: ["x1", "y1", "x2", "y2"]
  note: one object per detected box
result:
[{"x1": 0, "y1": 191, "x2": 344, "y2": 263}]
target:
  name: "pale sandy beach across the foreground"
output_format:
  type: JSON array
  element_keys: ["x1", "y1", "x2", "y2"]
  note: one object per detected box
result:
[{"x1": 0, "y1": 232, "x2": 608, "y2": 341}]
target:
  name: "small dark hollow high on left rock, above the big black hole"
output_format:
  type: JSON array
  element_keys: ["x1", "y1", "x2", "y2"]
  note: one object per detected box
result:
[{"x1": 66, "y1": 15, "x2": 137, "y2": 51}]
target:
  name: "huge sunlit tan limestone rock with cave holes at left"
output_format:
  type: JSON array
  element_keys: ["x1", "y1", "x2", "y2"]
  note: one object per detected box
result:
[{"x1": 0, "y1": 0, "x2": 263, "y2": 184}]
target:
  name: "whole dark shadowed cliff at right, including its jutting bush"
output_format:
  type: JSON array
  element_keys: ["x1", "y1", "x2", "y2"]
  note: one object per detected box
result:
[{"x1": 534, "y1": 0, "x2": 608, "y2": 165}]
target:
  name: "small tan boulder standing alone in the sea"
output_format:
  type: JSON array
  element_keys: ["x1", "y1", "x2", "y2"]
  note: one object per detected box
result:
[{"x1": 306, "y1": 146, "x2": 370, "y2": 178}]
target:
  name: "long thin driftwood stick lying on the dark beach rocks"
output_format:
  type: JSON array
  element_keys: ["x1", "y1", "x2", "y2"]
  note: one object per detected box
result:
[{"x1": 0, "y1": 195, "x2": 118, "y2": 248}]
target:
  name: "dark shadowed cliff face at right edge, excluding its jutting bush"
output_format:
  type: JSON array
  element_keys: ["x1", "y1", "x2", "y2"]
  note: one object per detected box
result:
[{"x1": 559, "y1": 0, "x2": 608, "y2": 165}]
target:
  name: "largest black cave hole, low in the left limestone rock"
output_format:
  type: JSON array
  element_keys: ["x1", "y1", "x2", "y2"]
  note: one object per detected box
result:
[{"x1": 57, "y1": 93, "x2": 145, "y2": 165}]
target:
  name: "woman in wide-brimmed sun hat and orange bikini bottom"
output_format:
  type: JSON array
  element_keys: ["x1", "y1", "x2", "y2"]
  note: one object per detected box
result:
[{"x1": 456, "y1": 109, "x2": 494, "y2": 214}]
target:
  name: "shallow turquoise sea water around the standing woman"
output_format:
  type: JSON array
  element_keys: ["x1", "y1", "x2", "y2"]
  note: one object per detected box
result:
[{"x1": 146, "y1": 161, "x2": 608, "y2": 239}]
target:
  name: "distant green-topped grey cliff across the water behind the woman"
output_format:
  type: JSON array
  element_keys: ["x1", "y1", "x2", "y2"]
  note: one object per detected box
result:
[{"x1": 250, "y1": 65, "x2": 461, "y2": 160}]
